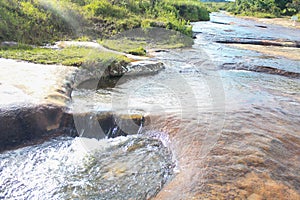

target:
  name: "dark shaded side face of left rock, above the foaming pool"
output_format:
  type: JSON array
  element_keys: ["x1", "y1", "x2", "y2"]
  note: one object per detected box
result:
[{"x1": 0, "y1": 105, "x2": 73, "y2": 151}]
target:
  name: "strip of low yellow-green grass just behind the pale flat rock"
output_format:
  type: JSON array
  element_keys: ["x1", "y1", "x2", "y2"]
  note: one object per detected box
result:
[{"x1": 0, "y1": 47, "x2": 130, "y2": 67}]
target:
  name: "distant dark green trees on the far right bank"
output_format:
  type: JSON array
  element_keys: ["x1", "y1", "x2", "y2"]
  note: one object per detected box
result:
[{"x1": 228, "y1": 0, "x2": 300, "y2": 18}]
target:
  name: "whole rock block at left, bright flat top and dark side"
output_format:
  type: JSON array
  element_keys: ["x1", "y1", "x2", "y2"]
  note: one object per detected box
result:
[{"x1": 0, "y1": 59, "x2": 76, "y2": 151}]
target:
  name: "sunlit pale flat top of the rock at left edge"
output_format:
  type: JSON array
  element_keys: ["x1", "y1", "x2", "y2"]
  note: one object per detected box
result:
[{"x1": 0, "y1": 58, "x2": 77, "y2": 107}]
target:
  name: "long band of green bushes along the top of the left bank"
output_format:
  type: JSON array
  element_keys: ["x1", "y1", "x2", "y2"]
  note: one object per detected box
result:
[{"x1": 0, "y1": 0, "x2": 209, "y2": 44}]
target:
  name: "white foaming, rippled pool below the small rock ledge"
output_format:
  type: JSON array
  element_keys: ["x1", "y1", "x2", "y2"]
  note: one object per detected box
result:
[{"x1": 0, "y1": 135, "x2": 173, "y2": 199}]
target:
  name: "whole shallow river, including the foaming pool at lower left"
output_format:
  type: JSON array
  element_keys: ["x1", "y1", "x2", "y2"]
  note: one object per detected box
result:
[{"x1": 0, "y1": 13, "x2": 300, "y2": 199}]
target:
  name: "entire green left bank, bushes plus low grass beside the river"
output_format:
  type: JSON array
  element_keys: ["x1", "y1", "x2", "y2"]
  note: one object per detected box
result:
[{"x1": 0, "y1": 0, "x2": 209, "y2": 67}]
